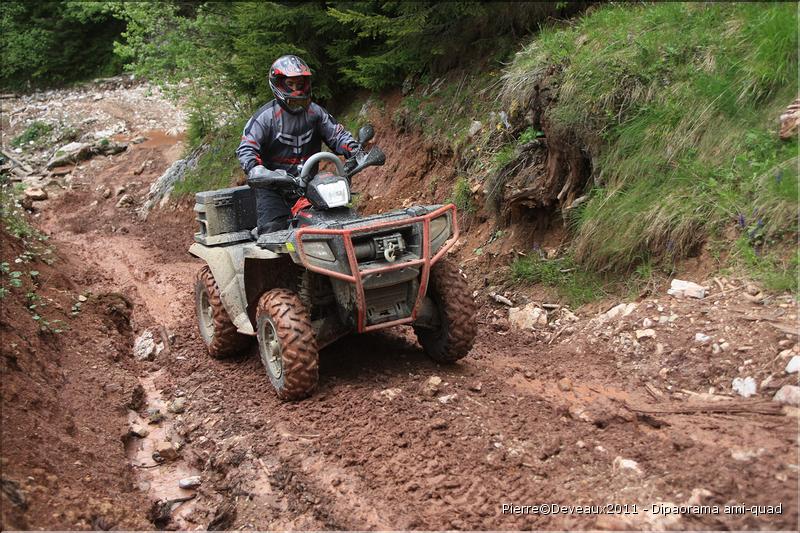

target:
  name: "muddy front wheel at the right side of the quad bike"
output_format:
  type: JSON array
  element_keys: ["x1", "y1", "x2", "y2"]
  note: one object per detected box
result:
[{"x1": 414, "y1": 259, "x2": 477, "y2": 363}]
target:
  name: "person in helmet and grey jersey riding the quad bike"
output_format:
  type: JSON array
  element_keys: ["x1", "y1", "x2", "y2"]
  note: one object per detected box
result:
[{"x1": 236, "y1": 55, "x2": 361, "y2": 234}]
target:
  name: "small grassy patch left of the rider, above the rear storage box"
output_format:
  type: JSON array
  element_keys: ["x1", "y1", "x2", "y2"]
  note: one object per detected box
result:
[{"x1": 173, "y1": 118, "x2": 246, "y2": 197}]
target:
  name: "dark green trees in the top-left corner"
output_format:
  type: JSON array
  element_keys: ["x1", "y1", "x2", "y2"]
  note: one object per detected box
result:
[{"x1": 0, "y1": 0, "x2": 124, "y2": 90}]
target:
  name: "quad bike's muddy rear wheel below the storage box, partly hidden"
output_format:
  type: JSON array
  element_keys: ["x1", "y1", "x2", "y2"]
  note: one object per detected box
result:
[{"x1": 194, "y1": 265, "x2": 250, "y2": 359}]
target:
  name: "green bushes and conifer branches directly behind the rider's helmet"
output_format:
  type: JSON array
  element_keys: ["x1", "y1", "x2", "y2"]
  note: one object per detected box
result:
[{"x1": 108, "y1": 0, "x2": 580, "y2": 119}]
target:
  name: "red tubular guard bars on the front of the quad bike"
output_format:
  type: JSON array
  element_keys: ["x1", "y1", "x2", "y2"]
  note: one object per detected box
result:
[{"x1": 295, "y1": 204, "x2": 459, "y2": 333}]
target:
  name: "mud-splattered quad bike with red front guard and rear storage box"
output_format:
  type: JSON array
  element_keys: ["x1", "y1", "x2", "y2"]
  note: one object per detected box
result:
[{"x1": 189, "y1": 126, "x2": 476, "y2": 400}]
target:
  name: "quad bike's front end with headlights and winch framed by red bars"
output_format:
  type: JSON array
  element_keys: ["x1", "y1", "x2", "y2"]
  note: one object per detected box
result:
[{"x1": 287, "y1": 204, "x2": 459, "y2": 333}]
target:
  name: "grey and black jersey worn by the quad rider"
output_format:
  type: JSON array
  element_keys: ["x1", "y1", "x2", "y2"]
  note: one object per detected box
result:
[{"x1": 236, "y1": 100, "x2": 358, "y2": 175}]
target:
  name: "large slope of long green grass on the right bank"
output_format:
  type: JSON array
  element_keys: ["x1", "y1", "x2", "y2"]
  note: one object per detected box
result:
[{"x1": 502, "y1": 2, "x2": 798, "y2": 278}]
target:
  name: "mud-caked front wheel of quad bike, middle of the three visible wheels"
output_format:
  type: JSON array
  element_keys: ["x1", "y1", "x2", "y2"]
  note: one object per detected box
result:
[{"x1": 256, "y1": 289, "x2": 319, "y2": 400}]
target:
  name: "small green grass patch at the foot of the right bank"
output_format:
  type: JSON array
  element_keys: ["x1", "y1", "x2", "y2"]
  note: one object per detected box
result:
[{"x1": 511, "y1": 254, "x2": 605, "y2": 308}]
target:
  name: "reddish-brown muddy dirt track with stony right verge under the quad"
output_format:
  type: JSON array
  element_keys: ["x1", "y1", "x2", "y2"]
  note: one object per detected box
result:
[{"x1": 3, "y1": 83, "x2": 798, "y2": 530}]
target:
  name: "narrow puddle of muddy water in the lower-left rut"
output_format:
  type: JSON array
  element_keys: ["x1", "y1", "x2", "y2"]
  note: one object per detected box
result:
[{"x1": 125, "y1": 371, "x2": 200, "y2": 530}]
